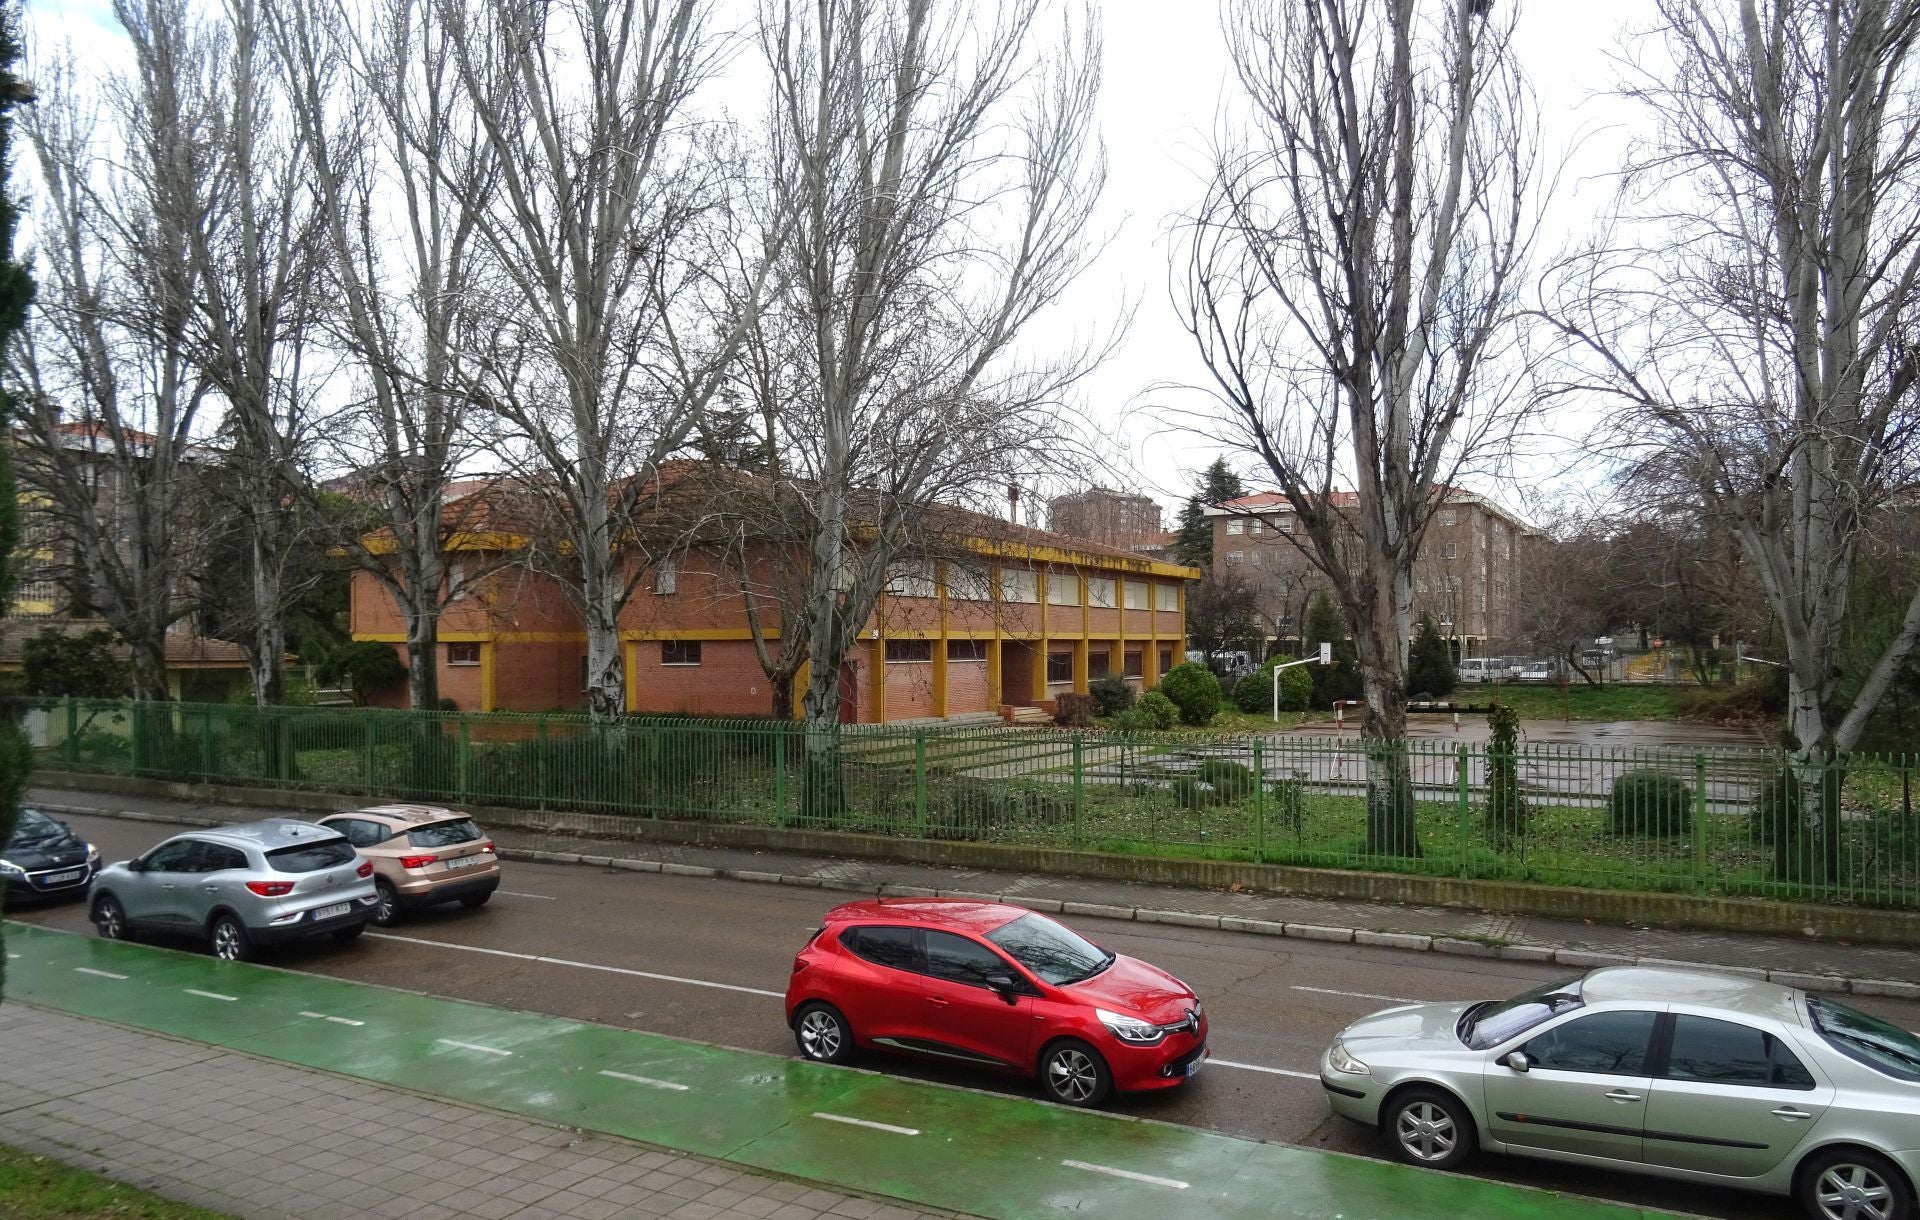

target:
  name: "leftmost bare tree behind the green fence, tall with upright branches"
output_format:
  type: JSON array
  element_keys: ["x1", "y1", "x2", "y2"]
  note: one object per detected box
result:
[{"x1": 8, "y1": 9, "x2": 227, "y2": 699}]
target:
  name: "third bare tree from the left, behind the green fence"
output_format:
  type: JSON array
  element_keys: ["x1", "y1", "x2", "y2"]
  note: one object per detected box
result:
[{"x1": 269, "y1": 0, "x2": 497, "y2": 709}]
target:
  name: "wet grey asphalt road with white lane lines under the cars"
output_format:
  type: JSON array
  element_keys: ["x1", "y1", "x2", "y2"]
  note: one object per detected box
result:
[{"x1": 12, "y1": 817, "x2": 1920, "y2": 1220}]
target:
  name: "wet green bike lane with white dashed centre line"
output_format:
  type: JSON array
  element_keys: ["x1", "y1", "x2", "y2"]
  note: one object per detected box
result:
[{"x1": 6, "y1": 922, "x2": 1667, "y2": 1220}]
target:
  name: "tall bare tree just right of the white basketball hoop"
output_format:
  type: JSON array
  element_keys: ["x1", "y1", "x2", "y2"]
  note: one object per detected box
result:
[{"x1": 1175, "y1": 0, "x2": 1536, "y2": 855}]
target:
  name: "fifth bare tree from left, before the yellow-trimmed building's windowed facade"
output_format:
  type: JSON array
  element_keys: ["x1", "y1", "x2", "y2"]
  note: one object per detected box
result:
[{"x1": 755, "y1": 0, "x2": 1106, "y2": 753}]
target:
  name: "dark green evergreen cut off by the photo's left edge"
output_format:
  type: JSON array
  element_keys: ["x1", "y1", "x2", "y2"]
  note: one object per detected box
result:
[{"x1": 0, "y1": 0, "x2": 33, "y2": 984}]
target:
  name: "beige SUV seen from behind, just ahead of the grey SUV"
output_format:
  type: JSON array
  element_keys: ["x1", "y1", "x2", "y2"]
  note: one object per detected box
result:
[{"x1": 321, "y1": 805, "x2": 499, "y2": 924}]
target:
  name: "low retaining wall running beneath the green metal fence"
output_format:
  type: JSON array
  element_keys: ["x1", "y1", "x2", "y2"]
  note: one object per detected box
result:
[{"x1": 33, "y1": 770, "x2": 1920, "y2": 947}]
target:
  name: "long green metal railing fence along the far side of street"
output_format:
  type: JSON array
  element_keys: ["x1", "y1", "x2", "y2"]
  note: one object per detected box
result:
[{"x1": 15, "y1": 699, "x2": 1920, "y2": 907}]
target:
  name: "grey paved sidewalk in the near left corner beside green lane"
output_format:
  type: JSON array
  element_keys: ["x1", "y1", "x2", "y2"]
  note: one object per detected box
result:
[{"x1": 0, "y1": 1003, "x2": 950, "y2": 1220}]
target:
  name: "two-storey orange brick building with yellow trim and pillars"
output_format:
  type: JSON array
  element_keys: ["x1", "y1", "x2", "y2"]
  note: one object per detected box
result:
[{"x1": 351, "y1": 480, "x2": 1198, "y2": 722}]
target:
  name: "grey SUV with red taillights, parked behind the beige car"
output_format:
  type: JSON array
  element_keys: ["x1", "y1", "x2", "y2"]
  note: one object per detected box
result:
[{"x1": 92, "y1": 818, "x2": 380, "y2": 961}]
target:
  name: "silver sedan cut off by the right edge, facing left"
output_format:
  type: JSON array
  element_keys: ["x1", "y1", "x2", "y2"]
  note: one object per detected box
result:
[{"x1": 1321, "y1": 966, "x2": 1920, "y2": 1220}]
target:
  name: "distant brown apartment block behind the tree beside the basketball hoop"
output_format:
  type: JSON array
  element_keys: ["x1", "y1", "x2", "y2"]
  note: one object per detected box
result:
[{"x1": 1206, "y1": 488, "x2": 1536, "y2": 657}]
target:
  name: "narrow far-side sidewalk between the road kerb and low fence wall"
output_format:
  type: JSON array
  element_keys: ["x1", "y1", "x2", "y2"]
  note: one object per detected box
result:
[{"x1": 25, "y1": 788, "x2": 1920, "y2": 999}]
